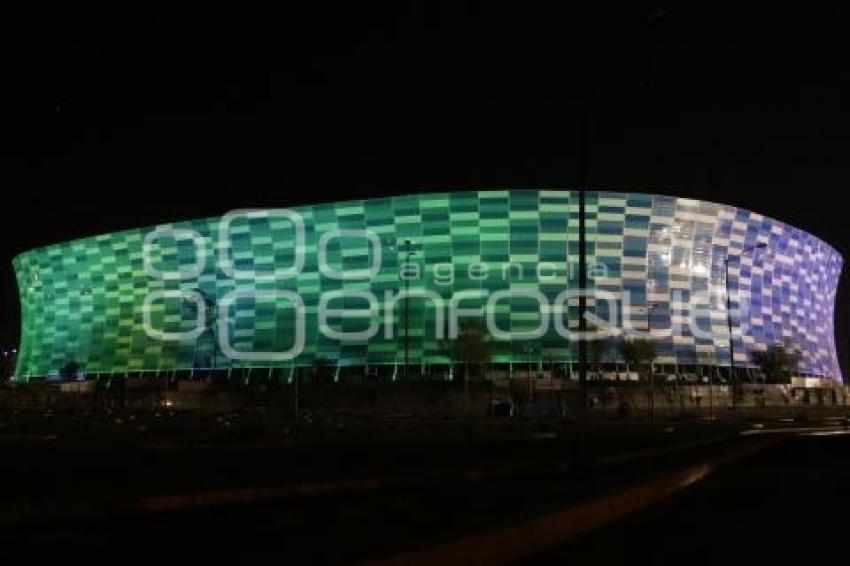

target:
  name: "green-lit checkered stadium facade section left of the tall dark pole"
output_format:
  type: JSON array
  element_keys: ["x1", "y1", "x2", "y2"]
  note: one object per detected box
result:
[{"x1": 14, "y1": 191, "x2": 570, "y2": 376}]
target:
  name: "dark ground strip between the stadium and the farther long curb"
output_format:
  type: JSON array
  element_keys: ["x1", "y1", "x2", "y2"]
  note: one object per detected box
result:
[{"x1": 0, "y1": 406, "x2": 756, "y2": 512}]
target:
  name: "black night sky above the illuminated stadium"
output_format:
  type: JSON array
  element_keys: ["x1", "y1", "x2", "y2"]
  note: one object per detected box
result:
[{"x1": 0, "y1": 0, "x2": 850, "y2": 373}]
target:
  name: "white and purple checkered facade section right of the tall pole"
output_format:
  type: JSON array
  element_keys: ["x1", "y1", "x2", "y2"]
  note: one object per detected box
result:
[{"x1": 586, "y1": 192, "x2": 842, "y2": 379}]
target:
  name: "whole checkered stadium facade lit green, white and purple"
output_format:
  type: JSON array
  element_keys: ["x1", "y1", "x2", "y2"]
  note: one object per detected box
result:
[{"x1": 14, "y1": 190, "x2": 842, "y2": 380}]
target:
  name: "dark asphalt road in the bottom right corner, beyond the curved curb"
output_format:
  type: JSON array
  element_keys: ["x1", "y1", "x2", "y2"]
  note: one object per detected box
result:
[{"x1": 529, "y1": 435, "x2": 850, "y2": 566}]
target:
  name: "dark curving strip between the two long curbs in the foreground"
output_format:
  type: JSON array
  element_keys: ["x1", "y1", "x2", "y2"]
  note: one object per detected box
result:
[{"x1": 0, "y1": 438, "x2": 756, "y2": 563}]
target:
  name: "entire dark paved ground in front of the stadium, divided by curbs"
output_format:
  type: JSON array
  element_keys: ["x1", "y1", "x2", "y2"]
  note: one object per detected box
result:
[{"x1": 0, "y1": 408, "x2": 850, "y2": 564}]
